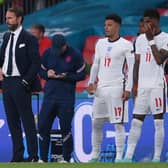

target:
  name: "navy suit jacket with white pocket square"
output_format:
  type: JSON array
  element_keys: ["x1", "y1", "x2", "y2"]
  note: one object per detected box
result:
[{"x1": 0, "y1": 29, "x2": 41, "y2": 92}]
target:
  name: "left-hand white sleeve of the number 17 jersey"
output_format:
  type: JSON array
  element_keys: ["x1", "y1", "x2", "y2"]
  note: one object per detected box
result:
[{"x1": 88, "y1": 42, "x2": 100, "y2": 85}]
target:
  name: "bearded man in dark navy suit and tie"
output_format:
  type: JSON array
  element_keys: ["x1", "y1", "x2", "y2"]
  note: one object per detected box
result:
[{"x1": 0, "y1": 7, "x2": 40, "y2": 162}]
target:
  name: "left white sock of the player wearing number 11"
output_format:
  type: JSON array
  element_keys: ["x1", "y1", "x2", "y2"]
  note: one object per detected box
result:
[{"x1": 125, "y1": 118, "x2": 143, "y2": 159}]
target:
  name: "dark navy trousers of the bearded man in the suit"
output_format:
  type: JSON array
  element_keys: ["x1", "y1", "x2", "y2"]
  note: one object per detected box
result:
[{"x1": 2, "y1": 77, "x2": 38, "y2": 161}]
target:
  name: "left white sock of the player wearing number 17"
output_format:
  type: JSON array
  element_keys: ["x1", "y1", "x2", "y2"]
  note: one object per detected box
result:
[{"x1": 92, "y1": 118, "x2": 108, "y2": 158}]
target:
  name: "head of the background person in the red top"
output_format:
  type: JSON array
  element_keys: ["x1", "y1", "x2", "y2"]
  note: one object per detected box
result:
[{"x1": 30, "y1": 24, "x2": 45, "y2": 40}]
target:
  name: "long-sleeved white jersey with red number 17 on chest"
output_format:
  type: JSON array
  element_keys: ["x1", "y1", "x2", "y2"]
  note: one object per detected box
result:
[{"x1": 89, "y1": 37, "x2": 134, "y2": 91}]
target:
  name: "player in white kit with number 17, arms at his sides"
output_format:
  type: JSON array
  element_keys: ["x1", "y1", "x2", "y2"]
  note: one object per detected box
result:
[{"x1": 88, "y1": 14, "x2": 134, "y2": 162}]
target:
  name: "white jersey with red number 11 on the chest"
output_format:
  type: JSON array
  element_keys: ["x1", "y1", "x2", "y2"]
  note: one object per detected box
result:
[{"x1": 135, "y1": 32, "x2": 168, "y2": 88}]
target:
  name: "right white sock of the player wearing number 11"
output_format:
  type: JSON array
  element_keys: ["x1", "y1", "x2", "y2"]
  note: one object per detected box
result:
[{"x1": 153, "y1": 119, "x2": 164, "y2": 160}]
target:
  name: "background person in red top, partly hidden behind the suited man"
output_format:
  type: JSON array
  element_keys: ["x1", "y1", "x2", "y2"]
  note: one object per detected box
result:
[{"x1": 30, "y1": 24, "x2": 51, "y2": 56}]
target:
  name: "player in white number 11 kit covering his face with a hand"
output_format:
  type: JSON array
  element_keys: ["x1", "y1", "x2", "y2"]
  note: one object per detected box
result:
[{"x1": 125, "y1": 9, "x2": 168, "y2": 162}]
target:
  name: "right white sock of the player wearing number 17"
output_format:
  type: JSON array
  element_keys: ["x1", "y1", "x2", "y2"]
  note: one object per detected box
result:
[{"x1": 114, "y1": 124, "x2": 126, "y2": 160}]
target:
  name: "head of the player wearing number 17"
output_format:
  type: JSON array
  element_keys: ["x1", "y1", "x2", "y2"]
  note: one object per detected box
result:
[{"x1": 104, "y1": 13, "x2": 122, "y2": 37}]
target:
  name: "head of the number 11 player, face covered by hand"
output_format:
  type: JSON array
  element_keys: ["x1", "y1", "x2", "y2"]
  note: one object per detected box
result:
[{"x1": 143, "y1": 8, "x2": 160, "y2": 28}]
